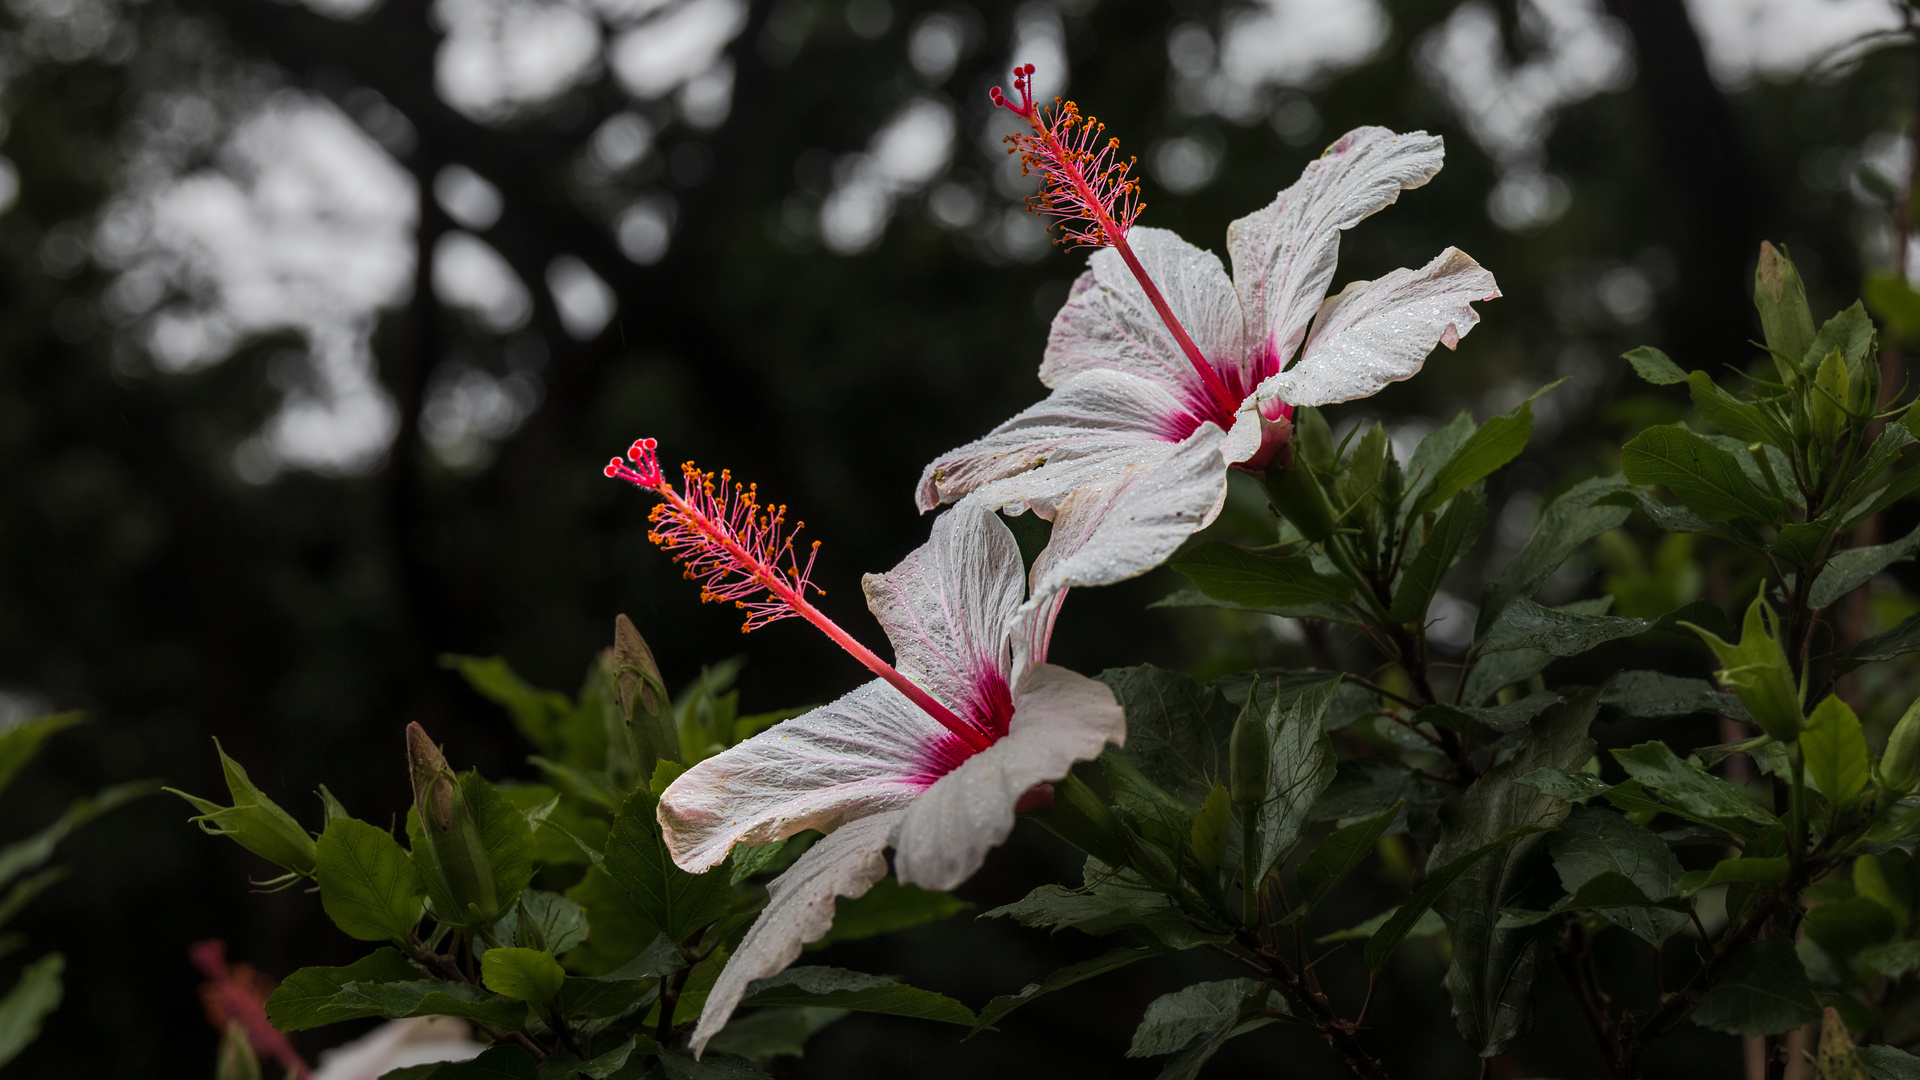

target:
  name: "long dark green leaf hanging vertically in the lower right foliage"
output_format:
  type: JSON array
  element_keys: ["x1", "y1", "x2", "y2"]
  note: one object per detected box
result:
[{"x1": 1428, "y1": 688, "x2": 1605, "y2": 1055}]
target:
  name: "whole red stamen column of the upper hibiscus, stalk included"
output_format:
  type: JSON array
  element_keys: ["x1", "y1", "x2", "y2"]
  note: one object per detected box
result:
[{"x1": 987, "y1": 63, "x2": 1240, "y2": 427}]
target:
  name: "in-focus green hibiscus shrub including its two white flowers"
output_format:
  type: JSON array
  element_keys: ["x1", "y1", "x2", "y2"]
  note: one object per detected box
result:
[{"x1": 176, "y1": 67, "x2": 1920, "y2": 1080}]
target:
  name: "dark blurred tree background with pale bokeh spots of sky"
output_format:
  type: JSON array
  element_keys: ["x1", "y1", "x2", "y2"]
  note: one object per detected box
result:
[{"x1": 0, "y1": 0, "x2": 1920, "y2": 1080}]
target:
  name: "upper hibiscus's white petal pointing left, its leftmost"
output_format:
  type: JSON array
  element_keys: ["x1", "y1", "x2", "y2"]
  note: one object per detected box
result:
[{"x1": 916, "y1": 371, "x2": 1192, "y2": 517}]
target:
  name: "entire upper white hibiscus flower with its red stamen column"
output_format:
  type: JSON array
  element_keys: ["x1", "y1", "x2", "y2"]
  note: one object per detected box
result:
[{"x1": 916, "y1": 65, "x2": 1500, "y2": 598}]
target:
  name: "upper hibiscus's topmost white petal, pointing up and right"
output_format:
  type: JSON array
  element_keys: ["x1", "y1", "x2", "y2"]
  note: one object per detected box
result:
[{"x1": 1227, "y1": 127, "x2": 1446, "y2": 365}]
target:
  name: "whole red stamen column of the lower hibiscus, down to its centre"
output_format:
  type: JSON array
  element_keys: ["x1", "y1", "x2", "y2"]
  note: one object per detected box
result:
[{"x1": 605, "y1": 438, "x2": 991, "y2": 749}]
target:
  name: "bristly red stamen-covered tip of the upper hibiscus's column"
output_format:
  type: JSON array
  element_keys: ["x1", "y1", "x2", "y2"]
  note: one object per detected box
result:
[{"x1": 987, "y1": 63, "x2": 1146, "y2": 248}]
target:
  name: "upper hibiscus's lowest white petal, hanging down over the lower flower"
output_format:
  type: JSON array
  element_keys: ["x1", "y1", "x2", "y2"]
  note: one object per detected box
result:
[{"x1": 1023, "y1": 423, "x2": 1227, "y2": 607}]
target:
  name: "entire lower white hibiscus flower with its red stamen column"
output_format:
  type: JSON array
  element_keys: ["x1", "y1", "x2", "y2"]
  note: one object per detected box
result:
[{"x1": 609, "y1": 440, "x2": 1125, "y2": 1051}]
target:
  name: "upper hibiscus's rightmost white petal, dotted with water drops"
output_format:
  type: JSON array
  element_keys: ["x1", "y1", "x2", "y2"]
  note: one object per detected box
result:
[{"x1": 1258, "y1": 248, "x2": 1500, "y2": 405}]
